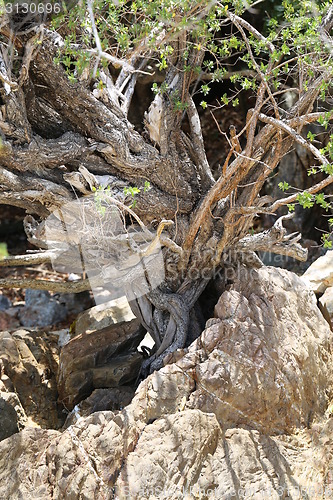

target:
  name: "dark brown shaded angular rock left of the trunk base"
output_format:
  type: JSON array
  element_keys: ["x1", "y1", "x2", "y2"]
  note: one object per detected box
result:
[{"x1": 58, "y1": 319, "x2": 145, "y2": 410}]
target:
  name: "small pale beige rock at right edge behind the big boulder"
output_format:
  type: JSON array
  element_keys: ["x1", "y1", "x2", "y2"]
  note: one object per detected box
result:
[{"x1": 303, "y1": 250, "x2": 333, "y2": 293}]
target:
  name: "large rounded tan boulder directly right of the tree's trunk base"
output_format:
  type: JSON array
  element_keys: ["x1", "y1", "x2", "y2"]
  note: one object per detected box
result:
[{"x1": 180, "y1": 267, "x2": 333, "y2": 433}]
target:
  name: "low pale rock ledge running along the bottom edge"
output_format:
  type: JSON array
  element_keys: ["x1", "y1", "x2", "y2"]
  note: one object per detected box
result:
[{"x1": 0, "y1": 405, "x2": 333, "y2": 500}]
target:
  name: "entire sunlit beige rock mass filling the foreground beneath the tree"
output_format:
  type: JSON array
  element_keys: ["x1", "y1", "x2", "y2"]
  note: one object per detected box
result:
[{"x1": 0, "y1": 268, "x2": 333, "y2": 500}]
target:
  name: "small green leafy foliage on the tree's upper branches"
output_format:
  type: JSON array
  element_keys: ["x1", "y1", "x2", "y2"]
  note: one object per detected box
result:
[{"x1": 48, "y1": 0, "x2": 333, "y2": 246}]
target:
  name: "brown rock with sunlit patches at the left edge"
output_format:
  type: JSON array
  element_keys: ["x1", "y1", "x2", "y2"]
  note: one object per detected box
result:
[{"x1": 0, "y1": 330, "x2": 63, "y2": 439}]
